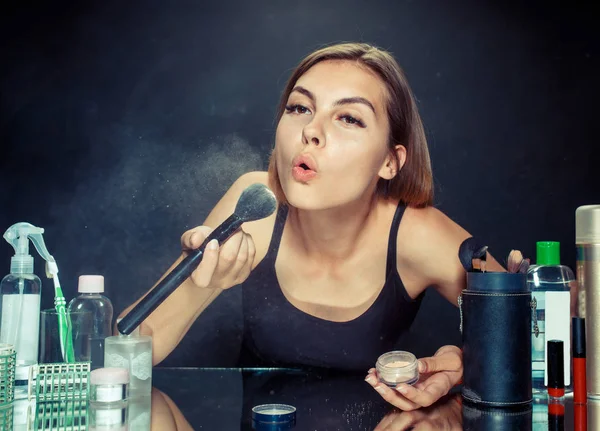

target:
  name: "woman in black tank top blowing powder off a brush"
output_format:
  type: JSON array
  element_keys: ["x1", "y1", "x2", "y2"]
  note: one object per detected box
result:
[{"x1": 120, "y1": 44, "x2": 502, "y2": 410}]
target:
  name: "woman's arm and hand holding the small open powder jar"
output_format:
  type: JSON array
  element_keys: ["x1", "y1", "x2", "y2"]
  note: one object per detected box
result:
[{"x1": 366, "y1": 207, "x2": 505, "y2": 410}]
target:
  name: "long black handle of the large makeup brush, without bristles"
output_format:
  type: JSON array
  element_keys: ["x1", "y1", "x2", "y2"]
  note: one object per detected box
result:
[{"x1": 117, "y1": 214, "x2": 244, "y2": 335}]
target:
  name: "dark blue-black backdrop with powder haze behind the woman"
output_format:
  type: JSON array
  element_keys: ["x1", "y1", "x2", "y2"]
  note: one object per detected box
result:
[{"x1": 0, "y1": 0, "x2": 600, "y2": 366}]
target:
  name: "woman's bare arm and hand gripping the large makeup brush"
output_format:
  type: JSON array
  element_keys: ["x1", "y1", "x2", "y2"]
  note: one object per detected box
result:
[{"x1": 120, "y1": 172, "x2": 266, "y2": 365}]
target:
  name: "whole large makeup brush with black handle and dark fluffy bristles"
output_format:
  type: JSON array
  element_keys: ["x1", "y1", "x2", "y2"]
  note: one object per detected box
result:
[{"x1": 117, "y1": 183, "x2": 277, "y2": 335}]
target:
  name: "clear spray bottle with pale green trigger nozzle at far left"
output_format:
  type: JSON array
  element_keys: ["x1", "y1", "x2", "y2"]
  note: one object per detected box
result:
[{"x1": 0, "y1": 223, "x2": 54, "y2": 399}]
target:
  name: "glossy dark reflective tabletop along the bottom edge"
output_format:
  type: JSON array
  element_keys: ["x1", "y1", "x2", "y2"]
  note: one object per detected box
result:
[{"x1": 0, "y1": 368, "x2": 600, "y2": 431}]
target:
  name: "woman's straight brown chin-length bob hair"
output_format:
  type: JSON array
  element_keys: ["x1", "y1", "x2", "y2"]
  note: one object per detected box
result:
[{"x1": 269, "y1": 43, "x2": 433, "y2": 207}]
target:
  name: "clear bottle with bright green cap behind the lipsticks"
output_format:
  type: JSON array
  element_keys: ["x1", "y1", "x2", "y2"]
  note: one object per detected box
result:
[{"x1": 527, "y1": 241, "x2": 575, "y2": 392}]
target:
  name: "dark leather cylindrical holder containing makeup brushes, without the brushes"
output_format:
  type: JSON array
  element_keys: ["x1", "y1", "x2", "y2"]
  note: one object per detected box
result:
[{"x1": 459, "y1": 272, "x2": 537, "y2": 407}]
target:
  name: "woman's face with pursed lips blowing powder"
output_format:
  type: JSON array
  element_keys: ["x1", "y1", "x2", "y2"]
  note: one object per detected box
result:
[{"x1": 275, "y1": 60, "x2": 390, "y2": 210}]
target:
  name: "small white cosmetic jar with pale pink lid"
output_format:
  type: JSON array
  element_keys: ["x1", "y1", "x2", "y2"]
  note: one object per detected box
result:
[{"x1": 90, "y1": 368, "x2": 129, "y2": 403}]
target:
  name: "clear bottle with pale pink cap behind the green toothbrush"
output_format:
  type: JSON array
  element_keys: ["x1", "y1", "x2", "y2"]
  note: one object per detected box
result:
[{"x1": 68, "y1": 275, "x2": 113, "y2": 370}]
